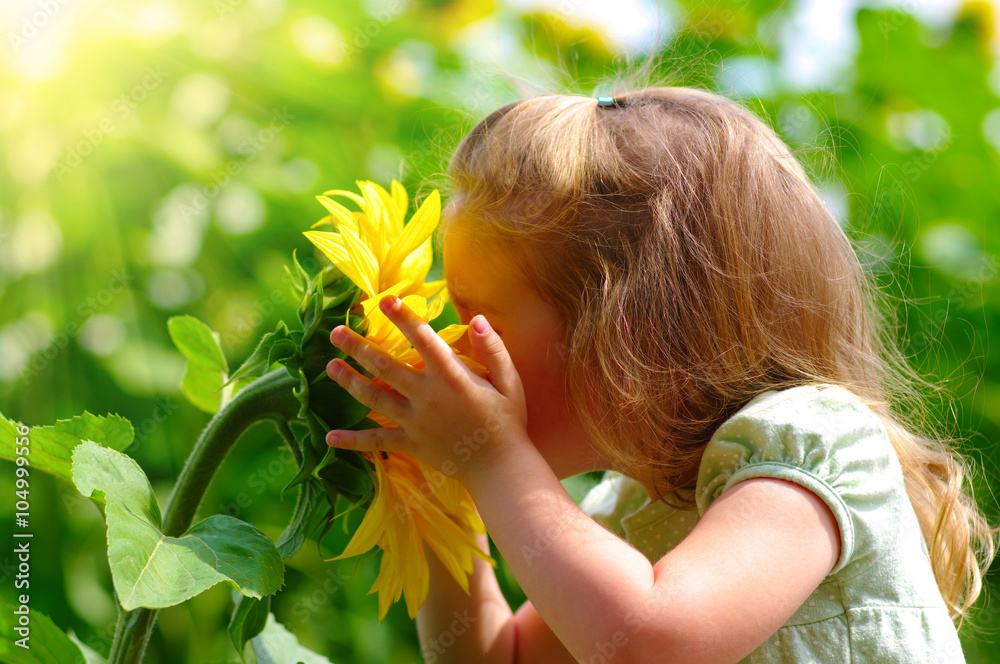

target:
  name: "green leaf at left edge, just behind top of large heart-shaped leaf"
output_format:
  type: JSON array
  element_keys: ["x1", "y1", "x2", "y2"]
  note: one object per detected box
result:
[{"x1": 0, "y1": 411, "x2": 134, "y2": 482}]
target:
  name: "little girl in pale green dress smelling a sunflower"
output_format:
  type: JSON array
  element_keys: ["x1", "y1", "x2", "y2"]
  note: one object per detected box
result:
[{"x1": 329, "y1": 87, "x2": 995, "y2": 664}]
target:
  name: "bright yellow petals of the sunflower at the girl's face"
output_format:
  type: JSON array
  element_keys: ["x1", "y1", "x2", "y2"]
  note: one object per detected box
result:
[{"x1": 305, "y1": 180, "x2": 496, "y2": 622}]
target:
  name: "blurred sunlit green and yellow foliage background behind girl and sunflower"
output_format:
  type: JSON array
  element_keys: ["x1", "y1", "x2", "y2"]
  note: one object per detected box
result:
[{"x1": 0, "y1": 0, "x2": 1000, "y2": 664}]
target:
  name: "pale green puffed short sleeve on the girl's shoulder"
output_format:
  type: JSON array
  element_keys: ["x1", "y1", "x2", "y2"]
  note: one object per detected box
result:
[{"x1": 695, "y1": 385, "x2": 908, "y2": 577}]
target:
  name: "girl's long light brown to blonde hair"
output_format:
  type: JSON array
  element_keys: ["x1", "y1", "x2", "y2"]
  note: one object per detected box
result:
[{"x1": 437, "y1": 87, "x2": 995, "y2": 627}]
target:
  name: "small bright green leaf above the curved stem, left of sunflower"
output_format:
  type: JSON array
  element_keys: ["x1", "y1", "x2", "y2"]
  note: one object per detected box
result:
[{"x1": 167, "y1": 316, "x2": 231, "y2": 413}]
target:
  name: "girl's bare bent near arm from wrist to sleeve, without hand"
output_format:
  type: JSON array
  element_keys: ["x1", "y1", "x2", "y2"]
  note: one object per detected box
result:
[{"x1": 464, "y1": 441, "x2": 840, "y2": 664}]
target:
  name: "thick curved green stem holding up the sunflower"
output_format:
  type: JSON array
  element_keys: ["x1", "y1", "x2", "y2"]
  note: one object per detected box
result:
[{"x1": 108, "y1": 368, "x2": 300, "y2": 664}]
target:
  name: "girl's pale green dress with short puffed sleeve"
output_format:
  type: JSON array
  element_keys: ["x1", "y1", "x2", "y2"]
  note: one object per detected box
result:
[{"x1": 581, "y1": 384, "x2": 965, "y2": 664}]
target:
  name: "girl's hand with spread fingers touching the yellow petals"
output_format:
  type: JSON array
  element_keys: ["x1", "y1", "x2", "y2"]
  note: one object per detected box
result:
[{"x1": 326, "y1": 296, "x2": 528, "y2": 480}]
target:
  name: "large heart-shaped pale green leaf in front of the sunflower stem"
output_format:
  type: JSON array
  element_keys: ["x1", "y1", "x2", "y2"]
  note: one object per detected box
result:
[{"x1": 73, "y1": 442, "x2": 284, "y2": 611}]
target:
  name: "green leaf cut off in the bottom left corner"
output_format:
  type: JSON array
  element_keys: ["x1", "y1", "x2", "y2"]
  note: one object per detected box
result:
[{"x1": 0, "y1": 603, "x2": 86, "y2": 664}]
